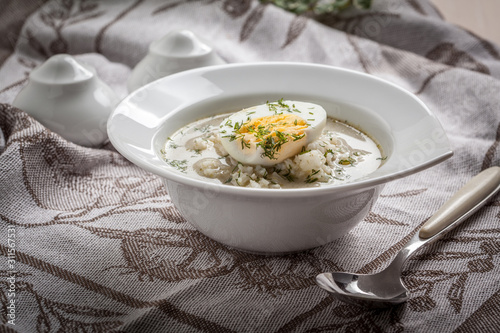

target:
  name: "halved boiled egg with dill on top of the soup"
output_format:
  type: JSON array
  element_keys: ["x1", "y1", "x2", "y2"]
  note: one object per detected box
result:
[{"x1": 219, "y1": 99, "x2": 327, "y2": 166}]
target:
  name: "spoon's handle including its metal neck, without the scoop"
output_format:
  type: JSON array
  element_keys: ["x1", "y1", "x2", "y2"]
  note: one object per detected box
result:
[{"x1": 391, "y1": 166, "x2": 500, "y2": 267}]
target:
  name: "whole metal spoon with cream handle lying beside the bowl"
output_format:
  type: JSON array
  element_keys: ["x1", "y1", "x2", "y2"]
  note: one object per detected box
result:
[{"x1": 316, "y1": 166, "x2": 500, "y2": 307}]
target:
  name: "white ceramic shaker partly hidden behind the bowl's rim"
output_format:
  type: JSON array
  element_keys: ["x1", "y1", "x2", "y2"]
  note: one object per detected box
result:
[{"x1": 127, "y1": 30, "x2": 225, "y2": 91}]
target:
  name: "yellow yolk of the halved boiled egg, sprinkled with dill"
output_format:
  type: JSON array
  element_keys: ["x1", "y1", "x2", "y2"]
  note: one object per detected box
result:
[{"x1": 238, "y1": 114, "x2": 309, "y2": 159}]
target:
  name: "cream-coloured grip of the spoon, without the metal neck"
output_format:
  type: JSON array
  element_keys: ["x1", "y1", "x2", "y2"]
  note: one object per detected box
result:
[{"x1": 419, "y1": 166, "x2": 500, "y2": 239}]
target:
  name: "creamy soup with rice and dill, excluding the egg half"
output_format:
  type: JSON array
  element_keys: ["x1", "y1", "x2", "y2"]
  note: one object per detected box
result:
[{"x1": 161, "y1": 102, "x2": 385, "y2": 189}]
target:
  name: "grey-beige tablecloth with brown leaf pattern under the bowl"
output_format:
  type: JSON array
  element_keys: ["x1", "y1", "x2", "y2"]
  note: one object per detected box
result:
[{"x1": 0, "y1": 0, "x2": 500, "y2": 332}]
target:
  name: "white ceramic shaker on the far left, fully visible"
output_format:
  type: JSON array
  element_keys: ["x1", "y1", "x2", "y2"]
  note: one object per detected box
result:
[{"x1": 12, "y1": 54, "x2": 119, "y2": 147}]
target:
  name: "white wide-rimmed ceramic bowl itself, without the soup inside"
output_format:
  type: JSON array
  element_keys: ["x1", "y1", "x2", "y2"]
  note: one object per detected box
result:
[{"x1": 108, "y1": 63, "x2": 452, "y2": 253}]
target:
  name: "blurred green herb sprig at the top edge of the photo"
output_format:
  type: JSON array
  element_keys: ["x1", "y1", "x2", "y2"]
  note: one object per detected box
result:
[{"x1": 260, "y1": 0, "x2": 372, "y2": 15}]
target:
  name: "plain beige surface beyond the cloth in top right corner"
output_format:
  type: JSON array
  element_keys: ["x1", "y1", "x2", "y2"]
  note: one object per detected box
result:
[{"x1": 431, "y1": 0, "x2": 500, "y2": 45}]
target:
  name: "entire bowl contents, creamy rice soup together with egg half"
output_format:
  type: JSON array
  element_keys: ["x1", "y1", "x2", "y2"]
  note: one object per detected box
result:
[{"x1": 161, "y1": 100, "x2": 384, "y2": 189}]
